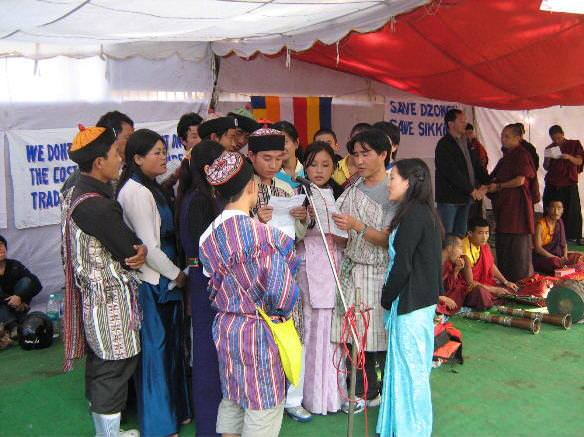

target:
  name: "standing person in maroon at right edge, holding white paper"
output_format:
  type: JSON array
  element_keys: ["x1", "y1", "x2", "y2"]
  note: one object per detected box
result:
[{"x1": 543, "y1": 125, "x2": 584, "y2": 244}]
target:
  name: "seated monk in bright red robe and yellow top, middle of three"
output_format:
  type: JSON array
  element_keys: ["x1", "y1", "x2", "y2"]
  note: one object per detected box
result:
[{"x1": 462, "y1": 217, "x2": 518, "y2": 296}]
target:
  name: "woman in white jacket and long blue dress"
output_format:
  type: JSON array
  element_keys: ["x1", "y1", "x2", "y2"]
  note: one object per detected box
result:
[{"x1": 118, "y1": 129, "x2": 191, "y2": 436}]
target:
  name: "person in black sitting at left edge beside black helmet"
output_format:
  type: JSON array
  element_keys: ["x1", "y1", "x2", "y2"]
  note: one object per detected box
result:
[{"x1": 0, "y1": 235, "x2": 42, "y2": 337}]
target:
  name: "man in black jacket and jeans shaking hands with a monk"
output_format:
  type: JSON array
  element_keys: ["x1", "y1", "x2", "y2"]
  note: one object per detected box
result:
[{"x1": 434, "y1": 109, "x2": 489, "y2": 236}]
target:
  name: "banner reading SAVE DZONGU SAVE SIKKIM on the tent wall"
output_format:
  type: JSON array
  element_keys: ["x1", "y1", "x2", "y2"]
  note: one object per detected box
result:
[{"x1": 385, "y1": 97, "x2": 472, "y2": 158}]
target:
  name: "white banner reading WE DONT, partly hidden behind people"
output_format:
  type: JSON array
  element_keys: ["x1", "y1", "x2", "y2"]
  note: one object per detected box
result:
[{"x1": 7, "y1": 120, "x2": 184, "y2": 229}]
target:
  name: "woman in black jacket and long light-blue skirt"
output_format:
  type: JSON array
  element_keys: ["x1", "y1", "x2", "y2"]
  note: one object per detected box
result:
[{"x1": 377, "y1": 159, "x2": 443, "y2": 437}]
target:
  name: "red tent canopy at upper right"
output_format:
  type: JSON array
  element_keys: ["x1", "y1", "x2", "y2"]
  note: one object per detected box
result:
[{"x1": 294, "y1": 0, "x2": 584, "y2": 109}]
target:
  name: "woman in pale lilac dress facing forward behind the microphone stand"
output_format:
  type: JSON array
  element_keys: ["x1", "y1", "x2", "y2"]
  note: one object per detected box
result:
[{"x1": 296, "y1": 141, "x2": 344, "y2": 415}]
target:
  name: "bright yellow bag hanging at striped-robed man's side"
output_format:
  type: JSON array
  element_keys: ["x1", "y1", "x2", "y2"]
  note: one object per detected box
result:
[{"x1": 257, "y1": 307, "x2": 302, "y2": 385}]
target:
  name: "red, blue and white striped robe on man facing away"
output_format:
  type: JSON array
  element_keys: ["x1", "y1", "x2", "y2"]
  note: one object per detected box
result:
[{"x1": 199, "y1": 212, "x2": 299, "y2": 410}]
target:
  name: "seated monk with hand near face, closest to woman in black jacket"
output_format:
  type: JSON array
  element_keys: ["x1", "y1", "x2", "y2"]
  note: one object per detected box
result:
[{"x1": 436, "y1": 235, "x2": 493, "y2": 315}]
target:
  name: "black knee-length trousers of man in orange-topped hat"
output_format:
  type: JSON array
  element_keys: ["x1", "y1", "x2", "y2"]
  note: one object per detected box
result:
[{"x1": 85, "y1": 347, "x2": 140, "y2": 414}]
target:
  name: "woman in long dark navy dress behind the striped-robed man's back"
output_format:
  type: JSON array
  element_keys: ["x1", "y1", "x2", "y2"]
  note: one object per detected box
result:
[{"x1": 177, "y1": 140, "x2": 223, "y2": 437}]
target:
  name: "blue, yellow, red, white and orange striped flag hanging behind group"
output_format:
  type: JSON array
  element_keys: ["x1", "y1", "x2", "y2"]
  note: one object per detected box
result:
[{"x1": 251, "y1": 96, "x2": 333, "y2": 147}]
